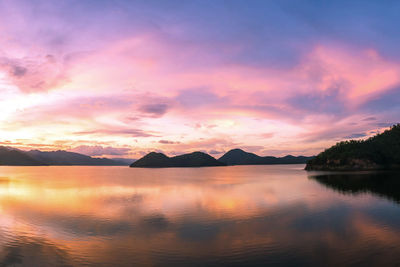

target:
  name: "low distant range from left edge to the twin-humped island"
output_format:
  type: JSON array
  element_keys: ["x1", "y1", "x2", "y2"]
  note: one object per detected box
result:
[{"x1": 0, "y1": 147, "x2": 134, "y2": 166}]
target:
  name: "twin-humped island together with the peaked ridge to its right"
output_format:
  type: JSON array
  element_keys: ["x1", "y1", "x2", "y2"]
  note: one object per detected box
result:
[{"x1": 130, "y1": 149, "x2": 313, "y2": 168}]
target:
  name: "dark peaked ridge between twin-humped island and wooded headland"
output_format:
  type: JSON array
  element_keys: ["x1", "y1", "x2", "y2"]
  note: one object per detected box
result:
[{"x1": 218, "y1": 148, "x2": 313, "y2": 165}]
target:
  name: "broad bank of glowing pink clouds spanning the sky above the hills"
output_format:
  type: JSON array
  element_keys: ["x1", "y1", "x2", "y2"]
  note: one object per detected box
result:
[{"x1": 0, "y1": 24, "x2": 400, "y2": 156}]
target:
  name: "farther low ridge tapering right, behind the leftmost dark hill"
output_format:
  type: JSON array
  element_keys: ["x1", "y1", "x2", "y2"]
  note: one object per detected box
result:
[{"x1": 25, "y1": 150, "x2": 127, "y2": 166}]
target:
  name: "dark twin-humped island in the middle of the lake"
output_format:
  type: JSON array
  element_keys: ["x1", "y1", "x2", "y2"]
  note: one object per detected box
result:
[{"x1": 130, "y1": 152, "x2": 225, "y2": 168}]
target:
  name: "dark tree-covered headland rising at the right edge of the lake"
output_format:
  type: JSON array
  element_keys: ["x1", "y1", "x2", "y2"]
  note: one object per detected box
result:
[{"x1": 306, "y1": 124, "x2": 400, "y2": 170}]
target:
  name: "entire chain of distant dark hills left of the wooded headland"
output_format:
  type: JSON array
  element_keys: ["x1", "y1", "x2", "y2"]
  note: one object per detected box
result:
[{"x1": 0, "y1": 147, "x2": 313, "y2": 168}]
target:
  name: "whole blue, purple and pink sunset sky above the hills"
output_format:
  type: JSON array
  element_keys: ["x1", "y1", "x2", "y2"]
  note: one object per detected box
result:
[{"x1": 0, "y1": 0, "x2": 400, "y2": 158}]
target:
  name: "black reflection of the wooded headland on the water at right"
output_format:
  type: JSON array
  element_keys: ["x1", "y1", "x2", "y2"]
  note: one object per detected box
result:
[{"x1": 309, "y1": 171, "x2": 400, "y2": 203}]
